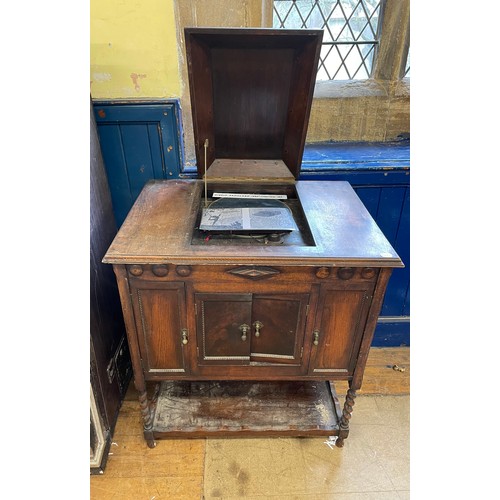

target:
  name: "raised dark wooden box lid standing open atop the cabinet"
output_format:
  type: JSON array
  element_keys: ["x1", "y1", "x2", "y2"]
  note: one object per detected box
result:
[{"x1": 185, "y1": 28, "x2": 323, "y2": 182}]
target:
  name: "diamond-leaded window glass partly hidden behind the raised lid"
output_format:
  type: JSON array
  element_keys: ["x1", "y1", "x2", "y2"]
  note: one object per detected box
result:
[{"x1": 273, "y1": 0, "x2": 383, "y2": 81}]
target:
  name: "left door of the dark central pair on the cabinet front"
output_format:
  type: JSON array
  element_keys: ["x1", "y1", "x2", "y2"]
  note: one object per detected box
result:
[{"x1": 195, "y1": 293, "x2": 252, "y2": 364}]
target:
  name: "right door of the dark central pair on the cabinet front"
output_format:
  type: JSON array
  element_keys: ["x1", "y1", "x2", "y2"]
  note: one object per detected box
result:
[{"x1": 250, "y1": 294, "x2": 309, "y2": 364}]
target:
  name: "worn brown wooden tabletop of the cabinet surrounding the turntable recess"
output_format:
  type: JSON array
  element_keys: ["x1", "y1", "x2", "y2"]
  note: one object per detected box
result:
[{"x1": 103, "y1": 180, "x2": 403, "y2": 267}]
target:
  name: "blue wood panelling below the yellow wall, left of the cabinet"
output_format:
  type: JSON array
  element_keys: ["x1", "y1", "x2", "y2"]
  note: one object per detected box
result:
[{"x1": 94, "y1": 100, "x2": 182, "y2": 226}]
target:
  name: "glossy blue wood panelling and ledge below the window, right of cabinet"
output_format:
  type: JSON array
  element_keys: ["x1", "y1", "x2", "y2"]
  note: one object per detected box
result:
[{"x1": 300, "y1": 137, "x2": 410, "y2": 347}]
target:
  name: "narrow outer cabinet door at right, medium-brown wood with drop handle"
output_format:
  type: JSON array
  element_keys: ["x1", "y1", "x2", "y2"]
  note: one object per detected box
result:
[{"x1": 309, "y1": 285, "x2": 370, "y2": 374}]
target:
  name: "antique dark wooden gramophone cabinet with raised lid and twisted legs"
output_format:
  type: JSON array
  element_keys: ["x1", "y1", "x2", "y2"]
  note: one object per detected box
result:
[{"x1": 103, "y1": 28, "x2": 403, "y2": 447}]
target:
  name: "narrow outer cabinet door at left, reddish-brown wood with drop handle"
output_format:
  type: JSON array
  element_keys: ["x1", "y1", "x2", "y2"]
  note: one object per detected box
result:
[{"x1": 130, "y1": 280, "x2": 188, "y2": 374}]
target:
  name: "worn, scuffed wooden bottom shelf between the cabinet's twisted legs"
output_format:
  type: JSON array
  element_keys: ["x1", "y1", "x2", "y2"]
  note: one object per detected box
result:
[{"x1": 153, "y1": 381, "x2": 341, "y2": 438}]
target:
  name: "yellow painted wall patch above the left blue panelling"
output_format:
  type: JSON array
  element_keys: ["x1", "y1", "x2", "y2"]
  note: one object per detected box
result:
[{"x1": 90, "y1": 0, "x2": 181, "y2": 99}]
